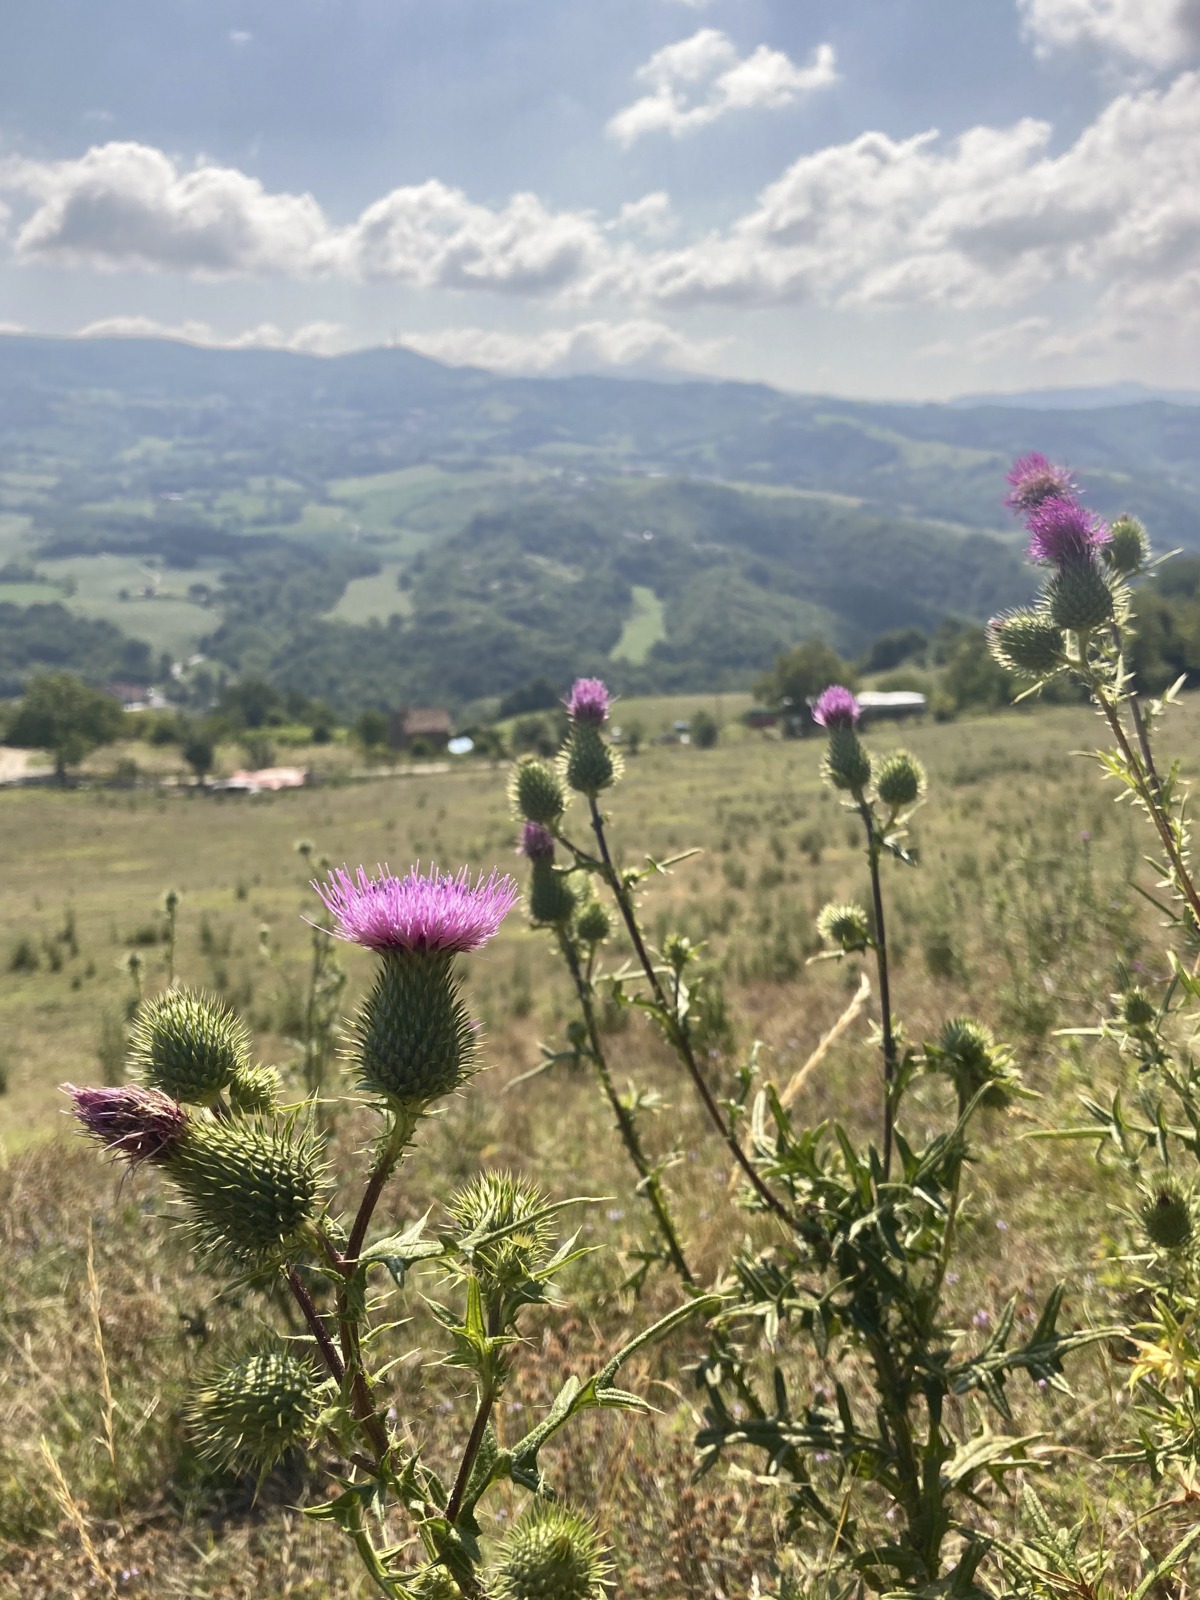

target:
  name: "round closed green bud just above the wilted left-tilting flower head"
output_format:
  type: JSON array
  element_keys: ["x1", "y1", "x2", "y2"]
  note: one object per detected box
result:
[{"x1": 130, "y1": 989, "x2": 250, "y2": 1106}]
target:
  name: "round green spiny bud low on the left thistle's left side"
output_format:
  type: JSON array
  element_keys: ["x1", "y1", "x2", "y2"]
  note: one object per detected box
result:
[{"x1": 187, "y1": 1346, "x2": 322, "y2": 1474}]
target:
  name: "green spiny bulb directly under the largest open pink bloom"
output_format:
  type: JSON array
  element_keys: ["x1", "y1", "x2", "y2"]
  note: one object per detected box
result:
[{"x1": 354, "y1": 950, "x2": 477, "y2": 1109}]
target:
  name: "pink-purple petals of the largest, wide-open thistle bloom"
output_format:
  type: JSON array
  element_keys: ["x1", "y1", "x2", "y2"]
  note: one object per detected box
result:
[{"x1": 312, "y1": 866, "x2": 517, "y2": 955}]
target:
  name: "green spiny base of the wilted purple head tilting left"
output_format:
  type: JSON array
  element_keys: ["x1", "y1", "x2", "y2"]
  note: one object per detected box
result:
[{"x1": 165, "y1": 1118, "x2": 325, "y2": 1267}]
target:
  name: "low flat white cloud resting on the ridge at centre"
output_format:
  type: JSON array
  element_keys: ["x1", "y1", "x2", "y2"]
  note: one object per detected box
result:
[{"x1": 395, "y1": 320, "x2": 723, "y2": 376}]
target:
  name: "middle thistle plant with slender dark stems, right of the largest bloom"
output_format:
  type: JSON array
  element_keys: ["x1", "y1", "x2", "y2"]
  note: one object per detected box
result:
[{"x1": 510, "y1": 680, "x2": 1099, "y2": 1597}]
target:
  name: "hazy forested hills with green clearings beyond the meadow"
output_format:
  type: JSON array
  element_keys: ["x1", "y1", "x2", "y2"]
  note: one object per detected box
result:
[{"x1": 0, "y1": 336, "x2": 1200, "y2": 706}]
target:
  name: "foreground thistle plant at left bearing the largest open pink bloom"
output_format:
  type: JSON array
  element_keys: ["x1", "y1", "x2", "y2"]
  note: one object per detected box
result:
[{"x1": 67, "y1": 869, "x2": 717, "y2": 1600}]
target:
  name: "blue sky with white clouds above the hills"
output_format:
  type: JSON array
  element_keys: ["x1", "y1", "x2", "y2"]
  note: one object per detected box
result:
[{"x1": 0, "y1": 0, "x2": 1200, "y2": 397}]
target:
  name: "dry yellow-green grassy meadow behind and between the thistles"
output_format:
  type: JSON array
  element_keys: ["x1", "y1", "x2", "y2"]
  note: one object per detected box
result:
[{"x1": 0, "y1": 696, "x2": 1200, "y2": 1600}]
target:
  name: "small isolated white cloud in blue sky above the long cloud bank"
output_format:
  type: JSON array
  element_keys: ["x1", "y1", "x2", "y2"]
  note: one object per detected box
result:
[{"x1": 608, "y1": 27, "x2": 837, "y2": 147}]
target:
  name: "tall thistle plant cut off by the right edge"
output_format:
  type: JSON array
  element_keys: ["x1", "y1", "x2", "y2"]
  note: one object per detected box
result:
[{"x1": 992, "y1": 456, "x2": 1200, "y2": 1474}]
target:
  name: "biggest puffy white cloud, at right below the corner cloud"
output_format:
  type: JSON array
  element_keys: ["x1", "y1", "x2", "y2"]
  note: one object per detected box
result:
[{"x1": 637, "y1": 74, "x2": 1200, "y2": 315}]
